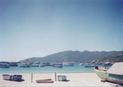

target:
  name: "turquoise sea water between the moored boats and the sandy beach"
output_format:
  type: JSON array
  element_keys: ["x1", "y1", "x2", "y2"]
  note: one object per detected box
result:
[{"x1": 0, "y1": 64, "x2": 94, "y2": 73}]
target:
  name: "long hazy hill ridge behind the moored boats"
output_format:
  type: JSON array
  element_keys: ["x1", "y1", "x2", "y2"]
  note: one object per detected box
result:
[{"x1": 0, "y1": 50, "x2": 123, "y2": 67}]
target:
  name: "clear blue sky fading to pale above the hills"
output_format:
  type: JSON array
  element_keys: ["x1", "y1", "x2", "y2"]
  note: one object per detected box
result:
[{"x1": 0, "y1": 0, "x2": 123, "y2": 61}]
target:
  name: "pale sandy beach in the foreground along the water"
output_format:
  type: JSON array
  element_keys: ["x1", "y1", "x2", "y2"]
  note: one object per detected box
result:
[{"x1": 0, "y1": 73, "x2": 120, "y2": 87}]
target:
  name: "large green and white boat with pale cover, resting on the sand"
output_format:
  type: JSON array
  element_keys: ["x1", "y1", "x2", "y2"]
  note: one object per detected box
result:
[{"x1": 95, "y1": 62, "x2": 123, "y2": 85}]
